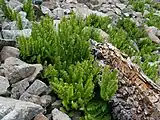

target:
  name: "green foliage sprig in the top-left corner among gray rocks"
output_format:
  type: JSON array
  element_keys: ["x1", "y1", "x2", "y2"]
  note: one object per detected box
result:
[{"x1": 0, "y1": 0, "x2": 17, "y2": 20}]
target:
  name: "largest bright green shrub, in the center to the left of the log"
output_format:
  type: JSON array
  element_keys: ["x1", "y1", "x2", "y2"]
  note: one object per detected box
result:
[{"x1": 18, "y1": 13, "x2": 119, "y2": 119}]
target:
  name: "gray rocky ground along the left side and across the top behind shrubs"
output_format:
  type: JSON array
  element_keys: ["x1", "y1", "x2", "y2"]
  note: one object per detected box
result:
[{"x1": 0, "y1": 0, "x2": 160, "y2": 120}]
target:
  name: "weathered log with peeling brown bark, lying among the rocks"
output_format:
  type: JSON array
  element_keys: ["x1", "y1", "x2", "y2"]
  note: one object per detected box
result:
[{"x1": 91, "y1": 40, "x2": 160, "y2": 120}]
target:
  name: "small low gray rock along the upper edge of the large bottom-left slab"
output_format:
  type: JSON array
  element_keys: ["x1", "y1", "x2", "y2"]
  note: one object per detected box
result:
[{"x1": 19, "y1": 92, "x2": 41, "y2": 105}]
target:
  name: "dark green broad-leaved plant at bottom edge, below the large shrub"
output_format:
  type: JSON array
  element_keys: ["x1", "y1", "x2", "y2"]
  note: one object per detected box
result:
[{"x1": 84, "y1": 100, "x2": 111, "y2": 120}]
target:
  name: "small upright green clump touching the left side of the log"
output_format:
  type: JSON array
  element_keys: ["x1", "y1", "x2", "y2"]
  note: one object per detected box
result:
[{"x1": 99, "y1": 66, "x2": 118, "y2": 101}]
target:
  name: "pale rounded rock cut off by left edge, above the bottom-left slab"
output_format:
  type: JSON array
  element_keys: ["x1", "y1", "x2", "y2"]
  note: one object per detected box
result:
[{"x1": 0, "y1": 76, "x2": 10, "y2": 95}]
